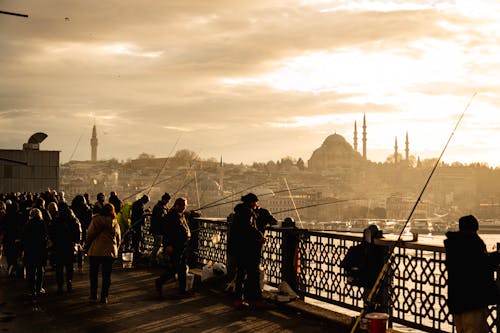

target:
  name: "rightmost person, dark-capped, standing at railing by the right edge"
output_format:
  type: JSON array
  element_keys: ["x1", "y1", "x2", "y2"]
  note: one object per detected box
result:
[{"x1": 444, "y1": 215, "x2": 500, "y2": 333}]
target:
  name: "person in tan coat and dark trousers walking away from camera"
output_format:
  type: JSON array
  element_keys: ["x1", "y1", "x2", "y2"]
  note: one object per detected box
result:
[{"x1": 87, "y1": 203, "x2": 121, "y2": 303}]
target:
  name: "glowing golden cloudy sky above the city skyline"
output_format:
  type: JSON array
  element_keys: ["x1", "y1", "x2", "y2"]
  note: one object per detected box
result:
[{"x1": 0, "y1": 0, "x2": 500, "y2": 167}]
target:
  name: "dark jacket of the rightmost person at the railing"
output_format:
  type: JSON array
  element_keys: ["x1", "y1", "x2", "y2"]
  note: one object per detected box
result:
[{"x1": 444, "y1": 231, "x2": 498, "y2": 314}]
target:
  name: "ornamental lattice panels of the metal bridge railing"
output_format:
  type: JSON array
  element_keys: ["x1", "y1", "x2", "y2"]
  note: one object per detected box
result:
[{"x1": 140, "y1": 218, "x2": 500, "y2": 333}]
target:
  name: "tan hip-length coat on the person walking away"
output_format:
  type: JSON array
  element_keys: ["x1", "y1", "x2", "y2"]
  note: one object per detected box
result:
[{"x1": 87, "y1": 214, "x2": 121, "y2": 258}]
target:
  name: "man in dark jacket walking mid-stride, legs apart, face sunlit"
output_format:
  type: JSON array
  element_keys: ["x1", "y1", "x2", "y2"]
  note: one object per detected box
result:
[{"x1": 155, "y1": 198, "x2": 191, "y2": 297}]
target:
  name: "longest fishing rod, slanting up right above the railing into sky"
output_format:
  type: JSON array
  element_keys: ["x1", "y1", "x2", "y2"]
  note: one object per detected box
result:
[{"x1": 350, "y1": 92, "x2": 477, "y2": 333}]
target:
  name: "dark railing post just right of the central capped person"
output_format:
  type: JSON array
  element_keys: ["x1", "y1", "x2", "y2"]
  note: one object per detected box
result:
[{"x1": 281, "y1": 218, "x2": 303, "y2": 298}]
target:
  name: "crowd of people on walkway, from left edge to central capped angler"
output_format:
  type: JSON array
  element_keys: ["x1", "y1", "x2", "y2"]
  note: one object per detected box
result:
[{"x1": 0, "y1": 190, "x2": 277, "y2": 308}]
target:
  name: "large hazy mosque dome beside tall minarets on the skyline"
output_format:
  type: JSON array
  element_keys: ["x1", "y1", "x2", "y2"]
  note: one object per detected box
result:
[{"x1": 308, "y1": 133, "x2": 364, "y2": 171}]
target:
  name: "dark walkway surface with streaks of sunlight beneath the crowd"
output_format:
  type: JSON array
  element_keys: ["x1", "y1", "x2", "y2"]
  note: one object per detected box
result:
[{"x1": 0, "y1": 262, "x2": 346, "y2": 333}]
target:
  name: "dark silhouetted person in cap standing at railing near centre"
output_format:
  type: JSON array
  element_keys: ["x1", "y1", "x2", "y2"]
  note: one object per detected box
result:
[{"x1": 230, "y1": 193, "x2": 270, "y2": 309}]
